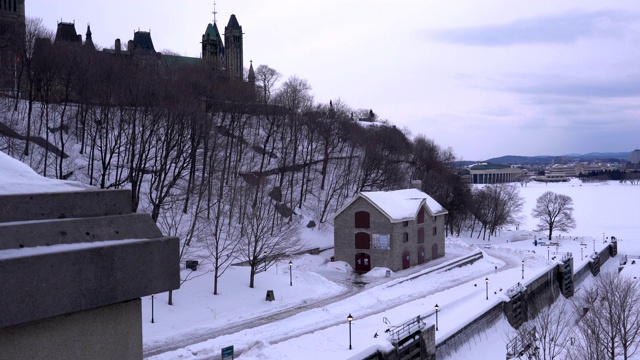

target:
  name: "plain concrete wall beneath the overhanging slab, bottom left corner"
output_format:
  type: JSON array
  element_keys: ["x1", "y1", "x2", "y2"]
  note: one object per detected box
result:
[{"x1": 0, "y1": 299, "x2": 142, "y2": 360}]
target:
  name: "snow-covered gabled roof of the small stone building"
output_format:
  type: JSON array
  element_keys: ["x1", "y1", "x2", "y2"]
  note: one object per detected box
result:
[{"x1": 332, "y1": 189, "x2": 448, "y2": 223}]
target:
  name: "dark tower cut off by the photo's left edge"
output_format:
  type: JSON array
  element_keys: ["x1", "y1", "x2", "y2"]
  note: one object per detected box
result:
[{"x1": 0, "y1": 0, "x2": 25, "y2": 92}]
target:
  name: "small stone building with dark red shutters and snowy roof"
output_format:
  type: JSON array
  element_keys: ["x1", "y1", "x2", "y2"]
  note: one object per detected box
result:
[{"x1": 333, "y1": 182, "x2": 448, "y2": 272}]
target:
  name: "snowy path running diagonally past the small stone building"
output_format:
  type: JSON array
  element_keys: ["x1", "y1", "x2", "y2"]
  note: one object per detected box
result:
[{"x1": 144, "y1": 249, "x2": 510, "y2": 359}]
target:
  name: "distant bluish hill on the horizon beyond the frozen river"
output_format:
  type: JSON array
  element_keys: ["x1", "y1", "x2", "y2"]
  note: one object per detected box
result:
[{"x1": 482, "y1": 151, "x2": 631, "y2": 165}]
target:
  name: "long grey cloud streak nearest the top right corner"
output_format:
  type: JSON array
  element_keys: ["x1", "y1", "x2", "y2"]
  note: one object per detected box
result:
[{"x1": 423, "y1": 10, "x2": 640, "y2": 46}]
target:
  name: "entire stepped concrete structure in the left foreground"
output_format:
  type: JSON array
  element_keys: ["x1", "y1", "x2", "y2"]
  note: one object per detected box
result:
[{"x1": 0, "y1": 189, "x2": 180, "y2": 359}]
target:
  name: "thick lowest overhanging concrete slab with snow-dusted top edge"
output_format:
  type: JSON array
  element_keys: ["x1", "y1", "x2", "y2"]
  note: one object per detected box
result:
[{"x1": 0, "y1": 237, "x2": 180, "y2": 328}]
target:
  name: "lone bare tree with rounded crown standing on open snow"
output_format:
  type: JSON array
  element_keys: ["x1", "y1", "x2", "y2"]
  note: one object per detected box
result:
[{"x1": 531, "y1": 191, "x2": 576, "y2": 240}]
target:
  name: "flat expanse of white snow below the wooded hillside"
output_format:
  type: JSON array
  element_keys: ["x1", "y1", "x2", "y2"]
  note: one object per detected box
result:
[{"x1": 143, "y1": 180, "x2": 640, "y2": 359}]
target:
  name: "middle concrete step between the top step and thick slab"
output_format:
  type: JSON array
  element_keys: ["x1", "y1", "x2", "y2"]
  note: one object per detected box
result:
[{"x1": 0, "y1": 214, "x2": 162, "y2": 250}]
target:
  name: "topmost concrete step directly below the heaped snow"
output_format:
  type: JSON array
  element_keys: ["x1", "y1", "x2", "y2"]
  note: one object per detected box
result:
[{"x1": 0, "y1": 189, "x2": 131, "y2": 222}]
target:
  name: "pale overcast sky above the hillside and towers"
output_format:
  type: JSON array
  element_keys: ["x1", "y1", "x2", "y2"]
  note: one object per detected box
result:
[{"x1": 26, "y1": 0, "x2": 640, "y2": 160}]
